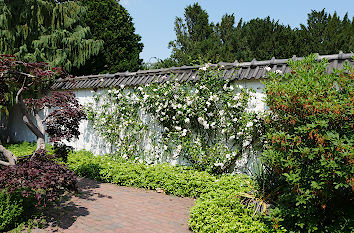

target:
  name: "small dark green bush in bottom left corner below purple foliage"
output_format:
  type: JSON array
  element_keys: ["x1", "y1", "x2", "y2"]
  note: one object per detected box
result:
[{"x1": 0, "y1": 189, "x2": 31, "y2": 232}]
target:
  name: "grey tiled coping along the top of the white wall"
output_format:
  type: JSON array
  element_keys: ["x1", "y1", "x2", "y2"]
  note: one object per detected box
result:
[{"x1": 51, "y1": 52, "x2": 354, "y2": 90}]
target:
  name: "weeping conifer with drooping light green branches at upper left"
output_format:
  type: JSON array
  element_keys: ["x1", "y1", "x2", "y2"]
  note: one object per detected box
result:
[{"x1": 0, "y1": 0, "x2": 102, "y2": 71}]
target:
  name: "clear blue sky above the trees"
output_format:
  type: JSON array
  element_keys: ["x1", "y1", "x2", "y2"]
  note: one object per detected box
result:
[{"x1": 120, "y1": 0, "x2": 354, "y2": 62}]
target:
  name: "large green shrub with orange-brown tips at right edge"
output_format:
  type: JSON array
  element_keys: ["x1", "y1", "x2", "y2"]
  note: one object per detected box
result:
[{"x1": 263, "y1": 55, "x2": 354, "y2": 232}]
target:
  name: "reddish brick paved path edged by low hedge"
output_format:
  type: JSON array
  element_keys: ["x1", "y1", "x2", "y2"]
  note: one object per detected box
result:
[{"x1": 32, "y1": 178, "x2": 194, "y2": 233}]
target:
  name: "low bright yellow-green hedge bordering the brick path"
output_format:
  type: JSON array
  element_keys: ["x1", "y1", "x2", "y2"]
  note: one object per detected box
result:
[{"x1": 67, "y1": 151, "x2": 279, "y2": 232}]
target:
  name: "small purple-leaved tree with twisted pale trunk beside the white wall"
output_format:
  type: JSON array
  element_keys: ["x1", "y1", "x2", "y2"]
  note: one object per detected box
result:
[{"x1": 0, "y1": 55, "x2": 85, "y2": 165}]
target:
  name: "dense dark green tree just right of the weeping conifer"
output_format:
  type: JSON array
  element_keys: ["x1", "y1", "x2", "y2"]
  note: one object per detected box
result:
[{"x1": 74, "y1": 0, "x2": 143, "y2": 75}]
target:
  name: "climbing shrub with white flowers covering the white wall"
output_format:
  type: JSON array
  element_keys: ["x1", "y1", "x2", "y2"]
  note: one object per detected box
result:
[{"x1": 87, "y1": 66, "x2": 259, "y2": 173}]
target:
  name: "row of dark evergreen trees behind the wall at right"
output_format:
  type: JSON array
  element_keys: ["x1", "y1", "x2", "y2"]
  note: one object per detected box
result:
[{"x1": 167, "y1": 3, "x2": 354, "y2": 67}]
